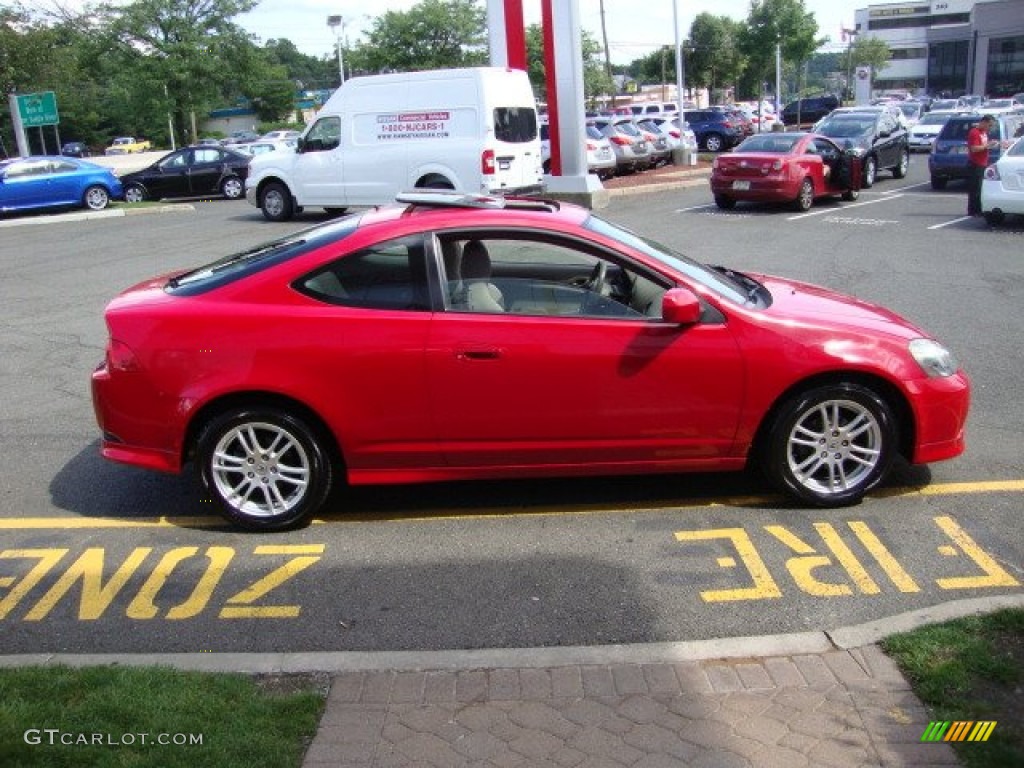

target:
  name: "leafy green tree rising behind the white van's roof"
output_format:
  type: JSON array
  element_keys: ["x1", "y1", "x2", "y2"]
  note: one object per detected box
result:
[{"x1": 348, "y1": 0, "x2": 487, "y2": 74}]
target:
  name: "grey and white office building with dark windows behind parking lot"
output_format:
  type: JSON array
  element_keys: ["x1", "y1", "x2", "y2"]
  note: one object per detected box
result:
[{"x1": 854, "y1": 0, "x2": 1024, "y2": 96}]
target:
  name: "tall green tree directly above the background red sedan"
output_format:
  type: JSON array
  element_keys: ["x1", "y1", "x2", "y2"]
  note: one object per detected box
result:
[{"x1": 739, "y1": 0, "x2": 828, "y2": 102}]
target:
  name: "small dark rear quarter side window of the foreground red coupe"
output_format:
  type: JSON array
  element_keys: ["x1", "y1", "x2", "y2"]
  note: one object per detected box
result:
[{"x1": 295, "y1": 236, "x2": 430, "y2": 311}]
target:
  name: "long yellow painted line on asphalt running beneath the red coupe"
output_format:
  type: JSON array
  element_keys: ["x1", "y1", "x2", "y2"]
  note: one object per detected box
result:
[{"x1": 0, "y1": 480, "x2": 1024, "y2": 530}]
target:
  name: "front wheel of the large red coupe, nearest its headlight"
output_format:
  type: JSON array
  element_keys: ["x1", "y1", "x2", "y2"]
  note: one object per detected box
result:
[{"x1": 761, "y1": 383, "x2": 896, "y2": 507}]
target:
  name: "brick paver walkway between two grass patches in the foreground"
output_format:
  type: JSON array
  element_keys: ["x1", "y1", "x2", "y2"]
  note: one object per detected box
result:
[{"x1": 303, "y1": 646, "x2": 959, "y2": 768}]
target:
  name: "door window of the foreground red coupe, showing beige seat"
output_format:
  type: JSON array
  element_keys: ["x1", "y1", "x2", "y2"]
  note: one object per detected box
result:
[{"x1": 439, "y1": 234, "x2": 666, "y2": 319}]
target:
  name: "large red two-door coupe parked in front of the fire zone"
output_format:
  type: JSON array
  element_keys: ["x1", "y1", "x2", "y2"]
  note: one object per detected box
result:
[{"x1": 92, "y1": 190, "x2": 970, "y2": 529}]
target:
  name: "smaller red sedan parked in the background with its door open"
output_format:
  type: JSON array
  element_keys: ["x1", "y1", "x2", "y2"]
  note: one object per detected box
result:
[{"x1": 711, "y1": 133, "x2": 861, "y2": 211}]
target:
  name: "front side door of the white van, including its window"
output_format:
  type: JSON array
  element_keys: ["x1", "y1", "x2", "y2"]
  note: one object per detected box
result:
[{"x1": 293, "y1": 115, "x2": 348, "y2": 208}]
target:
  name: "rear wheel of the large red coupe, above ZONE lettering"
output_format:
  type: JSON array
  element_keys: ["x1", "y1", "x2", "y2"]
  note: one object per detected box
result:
[{"x1": 196, "y1": 407, "x2": 334, "y2": 530}]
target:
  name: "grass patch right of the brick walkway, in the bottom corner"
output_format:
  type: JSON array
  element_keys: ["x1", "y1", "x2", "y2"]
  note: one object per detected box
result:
[{"x1": 882, "y1": 608, "x2": 1024, "y2": 768}]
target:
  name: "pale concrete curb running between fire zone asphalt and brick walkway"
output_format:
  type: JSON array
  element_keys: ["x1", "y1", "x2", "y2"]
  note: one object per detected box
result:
[{"x1": 0, "y1": 595, "x2": 1024, "y2": 674}]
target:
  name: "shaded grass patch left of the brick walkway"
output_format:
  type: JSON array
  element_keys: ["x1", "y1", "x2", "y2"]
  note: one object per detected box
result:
[{"x1": 0, "y1": 667, "x2": 326, "y2": 768}]
